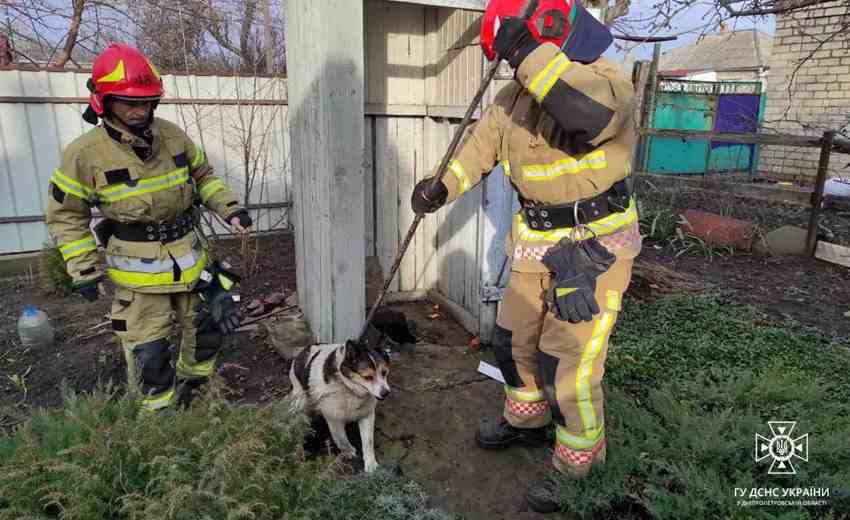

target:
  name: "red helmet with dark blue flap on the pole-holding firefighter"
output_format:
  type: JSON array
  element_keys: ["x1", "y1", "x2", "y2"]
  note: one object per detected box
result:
[{"x1": 481, "y1": 0, "x2": 614, "y2": 63}]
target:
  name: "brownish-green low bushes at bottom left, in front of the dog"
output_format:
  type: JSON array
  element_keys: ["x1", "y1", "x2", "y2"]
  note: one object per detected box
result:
[{"x1": 0, "y1": 378, "x2": 449, "y2": 520}]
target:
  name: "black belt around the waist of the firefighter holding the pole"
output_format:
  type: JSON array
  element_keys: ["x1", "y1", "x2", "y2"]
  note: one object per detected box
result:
[{"x1": 519, "y1": 179, "x2": 632, "y2": 231}]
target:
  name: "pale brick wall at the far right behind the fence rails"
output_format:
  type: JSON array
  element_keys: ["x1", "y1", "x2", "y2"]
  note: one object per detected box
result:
[{"x1": 759, "y1": 0, "x2": 850, "y2": 184}]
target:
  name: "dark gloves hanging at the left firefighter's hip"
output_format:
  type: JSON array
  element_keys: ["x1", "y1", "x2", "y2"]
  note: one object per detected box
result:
[{"x1": 195, "y1": 261, "x2": 243, "y2": 334}]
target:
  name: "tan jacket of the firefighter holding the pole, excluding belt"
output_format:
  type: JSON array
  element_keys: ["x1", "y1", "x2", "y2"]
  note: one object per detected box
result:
[{"x1": 422, "y1": 43, "x2": 640, "y2": 272}]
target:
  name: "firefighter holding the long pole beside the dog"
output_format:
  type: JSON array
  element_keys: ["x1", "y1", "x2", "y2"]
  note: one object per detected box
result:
[{"x1": 411, "y1": 0, "x2": 641, "y2": 512}]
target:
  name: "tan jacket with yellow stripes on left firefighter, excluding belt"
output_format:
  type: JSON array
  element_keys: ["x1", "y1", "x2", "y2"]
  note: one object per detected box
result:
[{"x1": 47, "y1": 115, "x2": 241, "y2": 293}]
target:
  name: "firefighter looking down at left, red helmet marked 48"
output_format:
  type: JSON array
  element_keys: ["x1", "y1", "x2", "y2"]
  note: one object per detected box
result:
[{"x1": 47, "y1": 45, "x2": 251, "y2": 410}]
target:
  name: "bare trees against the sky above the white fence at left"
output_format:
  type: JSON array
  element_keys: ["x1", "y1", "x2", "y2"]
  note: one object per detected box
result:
[{"x1": 0, "y1": 0, "x2": 284, "y2": 73}]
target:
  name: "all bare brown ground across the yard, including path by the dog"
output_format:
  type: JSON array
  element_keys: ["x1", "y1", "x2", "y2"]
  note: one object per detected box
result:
[{"x1": 0, "y1": 211, "x2": 850, "y2": 520}]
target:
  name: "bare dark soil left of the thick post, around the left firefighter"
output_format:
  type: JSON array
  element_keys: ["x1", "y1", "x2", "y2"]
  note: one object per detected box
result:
[{"x1": 0, "y1": 233, "x2": 295, "y2": 414}]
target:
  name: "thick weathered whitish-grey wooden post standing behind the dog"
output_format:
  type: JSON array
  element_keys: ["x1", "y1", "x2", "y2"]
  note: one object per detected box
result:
[{"x1": 286, "y1": 0, "x2": 366, "y2": 343}]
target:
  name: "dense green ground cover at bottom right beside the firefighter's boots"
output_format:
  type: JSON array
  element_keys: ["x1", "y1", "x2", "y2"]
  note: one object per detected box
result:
[{"x1": 561, "y1": 296, "x2": 850, "y2": 519}]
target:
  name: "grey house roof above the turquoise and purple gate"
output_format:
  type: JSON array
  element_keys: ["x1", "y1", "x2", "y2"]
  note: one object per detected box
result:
[{"x1": 658, "y1": 29, "x2": 773, "y2": 73}]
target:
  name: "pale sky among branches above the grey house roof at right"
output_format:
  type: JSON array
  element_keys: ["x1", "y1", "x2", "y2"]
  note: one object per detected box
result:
[{"x1": 606, "y1": 0, "x2": 776, "y2": 61}]
